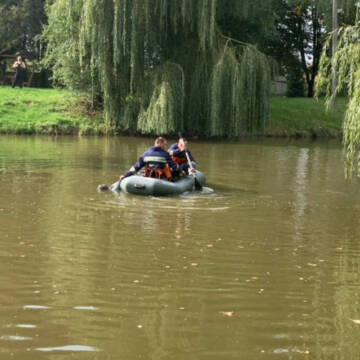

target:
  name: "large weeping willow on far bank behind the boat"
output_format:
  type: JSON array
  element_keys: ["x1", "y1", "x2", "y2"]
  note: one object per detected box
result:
[{"x1": 44, "y1": 0, "x2": 271, "y2": 137}]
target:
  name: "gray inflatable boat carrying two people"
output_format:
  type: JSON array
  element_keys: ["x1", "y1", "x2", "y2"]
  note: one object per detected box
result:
[{"x1": 110, "y1": 171, "x2": 205, "y2": 196}]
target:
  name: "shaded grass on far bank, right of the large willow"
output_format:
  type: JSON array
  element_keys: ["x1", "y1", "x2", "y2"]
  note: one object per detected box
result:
[{"x1": 266, "y1": 97, "x2": 346, "y2": 137}]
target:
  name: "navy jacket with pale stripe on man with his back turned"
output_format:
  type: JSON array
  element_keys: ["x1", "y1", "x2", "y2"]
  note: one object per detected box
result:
[{"x1": 124, "y1": 146, "x2": 178, "y2": 180}]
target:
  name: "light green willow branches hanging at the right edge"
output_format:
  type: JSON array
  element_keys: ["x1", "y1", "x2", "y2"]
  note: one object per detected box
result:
[{"x1": 316, "y1": 22, "x2": 360, "y2": 176}]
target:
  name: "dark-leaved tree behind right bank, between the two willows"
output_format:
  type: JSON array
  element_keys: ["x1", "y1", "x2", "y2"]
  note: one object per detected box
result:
[{"x1": 265, "y1": 0, "x2": 355, "y2": 97}]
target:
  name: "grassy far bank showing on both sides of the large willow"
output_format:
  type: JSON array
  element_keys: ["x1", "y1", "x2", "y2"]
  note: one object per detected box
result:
[{"x1": 0, "y1": 87, "x2": 345, "y2": 136}]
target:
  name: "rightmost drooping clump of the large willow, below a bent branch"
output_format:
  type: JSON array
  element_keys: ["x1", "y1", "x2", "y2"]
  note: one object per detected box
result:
[{"x1": 210, "y1": 44, "x2": 270, "y2": 136}]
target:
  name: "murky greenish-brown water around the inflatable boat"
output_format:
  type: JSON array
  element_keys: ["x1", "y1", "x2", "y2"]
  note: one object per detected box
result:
[{"x1": 0, "y1": 137, "x2": 360, "y2": 360}]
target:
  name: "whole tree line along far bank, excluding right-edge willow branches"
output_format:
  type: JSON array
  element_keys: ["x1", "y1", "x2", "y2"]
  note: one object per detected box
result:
[{"x1": 0, "y1": 0, "x2": 356, "y2": 137}]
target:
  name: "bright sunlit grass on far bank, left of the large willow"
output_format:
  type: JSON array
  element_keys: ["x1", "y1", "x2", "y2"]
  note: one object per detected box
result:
[{"x1": 0, "y1": 86, "x2": 102, "y2": 134}]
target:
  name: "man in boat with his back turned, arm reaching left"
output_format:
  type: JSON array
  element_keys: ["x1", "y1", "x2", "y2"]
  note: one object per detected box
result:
[{"x1": 120, "y1": 137, "x2": 179, "y2": 181}]
